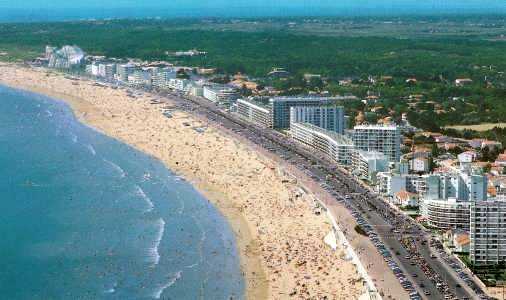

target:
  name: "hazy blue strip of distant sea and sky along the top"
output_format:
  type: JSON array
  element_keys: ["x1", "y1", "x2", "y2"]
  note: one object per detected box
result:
[{"x1": 0, "y1": 0, "x2": 506, "y2": 21}]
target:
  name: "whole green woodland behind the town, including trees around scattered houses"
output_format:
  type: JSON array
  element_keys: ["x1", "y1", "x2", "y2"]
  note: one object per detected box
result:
[{"x1": 0, "y1": 20, "x2": 506, "y2": 131}]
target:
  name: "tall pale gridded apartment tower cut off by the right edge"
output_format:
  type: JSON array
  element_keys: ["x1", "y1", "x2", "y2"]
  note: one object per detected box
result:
[{"x1": 469, "y1": 199, "x2": 506, "y2": 265}]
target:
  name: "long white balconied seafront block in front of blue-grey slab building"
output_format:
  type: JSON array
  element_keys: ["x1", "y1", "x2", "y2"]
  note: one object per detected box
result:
[{"x1": 290, "y1": 122, "x2": 354, "y2": 165}]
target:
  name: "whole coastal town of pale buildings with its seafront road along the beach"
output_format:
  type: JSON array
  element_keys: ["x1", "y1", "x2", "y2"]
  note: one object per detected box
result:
[{"x1": 17, "y1": 46, "x2": 506, "y2": 299}]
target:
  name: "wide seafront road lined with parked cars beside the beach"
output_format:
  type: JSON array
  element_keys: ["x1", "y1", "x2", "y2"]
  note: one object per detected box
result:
[{"x1": 149, "y1": 92, "x2": 490, "y2": 299}]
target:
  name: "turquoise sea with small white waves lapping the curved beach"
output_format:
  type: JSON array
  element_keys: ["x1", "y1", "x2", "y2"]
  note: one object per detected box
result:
[{"x1": 0, "y1": 86, "x2": 244, "y2": 299}]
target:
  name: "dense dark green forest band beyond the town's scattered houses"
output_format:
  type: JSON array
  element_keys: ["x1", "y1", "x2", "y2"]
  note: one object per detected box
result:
[{"x1": 0, "y1": 20, "x2": 506, "y2": 80}]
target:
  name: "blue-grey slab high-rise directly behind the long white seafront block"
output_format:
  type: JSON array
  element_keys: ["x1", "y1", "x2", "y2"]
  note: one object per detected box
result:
[{"x1": 290, "y1": 105, "x2": 345, "y2": 134}]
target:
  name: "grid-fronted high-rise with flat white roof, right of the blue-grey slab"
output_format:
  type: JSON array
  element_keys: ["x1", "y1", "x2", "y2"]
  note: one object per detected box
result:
[{"x1": 353, "y1": 125, "x2": 401, "y2": 162}]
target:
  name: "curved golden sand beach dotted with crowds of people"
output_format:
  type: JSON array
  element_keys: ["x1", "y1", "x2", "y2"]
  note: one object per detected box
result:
[{"x1": 0, "y1": 63, "x2": 364, "y2": 299}]
